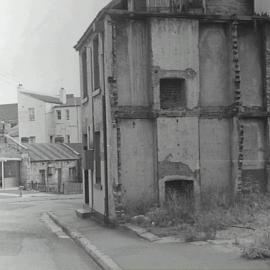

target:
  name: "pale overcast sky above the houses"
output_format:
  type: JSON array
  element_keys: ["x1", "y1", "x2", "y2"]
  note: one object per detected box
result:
[{"x1": 0, "y1": 0, "x2": 270, "y2": 104}]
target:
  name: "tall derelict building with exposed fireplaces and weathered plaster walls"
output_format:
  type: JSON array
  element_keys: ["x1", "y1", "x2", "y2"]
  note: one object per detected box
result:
[{"x1": 76, "y1": 0, "x2": 270, "y2": 223}]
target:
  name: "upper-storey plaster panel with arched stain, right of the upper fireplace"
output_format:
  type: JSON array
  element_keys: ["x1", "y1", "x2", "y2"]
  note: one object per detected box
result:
[{"x1": 199, "y1": 23, "x2": 233, "y2": 106}]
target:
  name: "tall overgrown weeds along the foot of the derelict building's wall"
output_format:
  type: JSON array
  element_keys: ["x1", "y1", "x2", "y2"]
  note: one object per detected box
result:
[{"x1": 129, "y1": 193, "x2": 270, "y2": 241}]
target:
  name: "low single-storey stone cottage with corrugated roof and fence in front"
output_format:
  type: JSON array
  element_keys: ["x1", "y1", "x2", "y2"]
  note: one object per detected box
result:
[{"x1": 0, "y1": 133, "x2": 82, "y2": 193}]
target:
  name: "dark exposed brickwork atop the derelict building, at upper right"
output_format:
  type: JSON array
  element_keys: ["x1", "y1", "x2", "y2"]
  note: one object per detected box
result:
[{"x1": 206, "y1": 0, "x2": 254, "y2": 15}]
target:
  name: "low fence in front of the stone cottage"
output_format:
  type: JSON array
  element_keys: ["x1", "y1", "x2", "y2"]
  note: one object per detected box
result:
[{"x1": 25, "y1": 182, "x2": 83, "y2": 194}]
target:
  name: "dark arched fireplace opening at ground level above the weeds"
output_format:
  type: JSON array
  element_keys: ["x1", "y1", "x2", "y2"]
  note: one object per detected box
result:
[{"x1": 165, "y1": 180, "x2": 194, "y2": 204}]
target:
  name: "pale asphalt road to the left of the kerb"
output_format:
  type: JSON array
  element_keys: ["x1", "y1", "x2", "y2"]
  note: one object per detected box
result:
[{"x1": 0, "y1": 193, "x2": 99, "y2": 270}]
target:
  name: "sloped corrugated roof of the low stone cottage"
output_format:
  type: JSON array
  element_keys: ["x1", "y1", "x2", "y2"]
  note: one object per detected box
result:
[{"x1": 24, "y1": 143, "x2": 80, "y2": 162}]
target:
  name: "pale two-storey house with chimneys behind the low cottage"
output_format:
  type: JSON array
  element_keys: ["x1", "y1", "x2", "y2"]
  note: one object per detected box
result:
[{"x1": 18, "y1": 85, "x2": 81, "y2": 143}]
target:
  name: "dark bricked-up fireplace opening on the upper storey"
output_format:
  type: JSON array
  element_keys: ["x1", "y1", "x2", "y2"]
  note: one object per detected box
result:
[{"x1": 160, "y1": 78, "x2": 186, "y2": 110}]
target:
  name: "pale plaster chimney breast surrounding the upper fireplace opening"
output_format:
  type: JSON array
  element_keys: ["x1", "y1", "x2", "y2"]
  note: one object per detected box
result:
[{"x1": 150, "y1": 18, "x2": 199, "y2": 109}]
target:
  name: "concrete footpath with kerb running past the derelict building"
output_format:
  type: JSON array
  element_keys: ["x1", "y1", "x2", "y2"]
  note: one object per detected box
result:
[{"x1": 48, "y1": 206, "x2": 270, "y2": 270}]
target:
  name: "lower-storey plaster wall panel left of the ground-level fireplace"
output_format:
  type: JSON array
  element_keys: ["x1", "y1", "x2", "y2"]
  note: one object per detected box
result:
[{"x1": 119, "y1": 119, "x2": 156, "y2": 208}]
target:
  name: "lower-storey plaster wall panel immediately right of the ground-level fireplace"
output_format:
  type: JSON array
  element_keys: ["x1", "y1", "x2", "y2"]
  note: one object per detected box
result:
[{"x1": 200, "y1": 119, "x2": 231, "y2": 195}]
